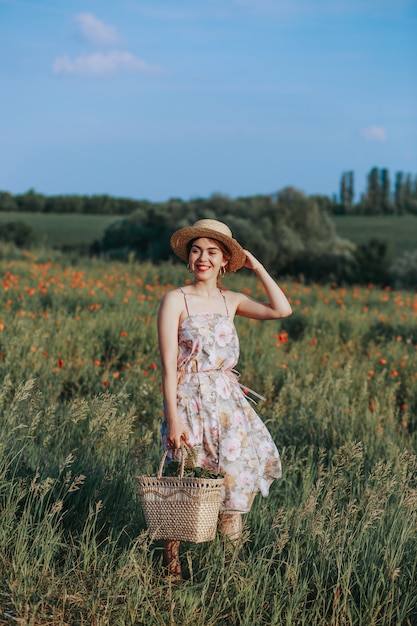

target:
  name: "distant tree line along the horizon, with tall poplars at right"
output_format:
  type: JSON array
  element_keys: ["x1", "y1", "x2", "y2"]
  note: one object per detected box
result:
[{"x1": 0, "y1": 167, "x2": 417, "y2": 215}]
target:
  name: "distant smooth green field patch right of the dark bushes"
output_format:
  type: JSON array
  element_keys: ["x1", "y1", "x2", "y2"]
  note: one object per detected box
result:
[{"x1": 333, "y1": 215, "x2": 417, "y2": 256}]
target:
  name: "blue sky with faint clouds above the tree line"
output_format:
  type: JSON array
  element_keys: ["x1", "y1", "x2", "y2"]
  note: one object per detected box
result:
[{"x1": 0, "y1": 0, "x2": 417, "y2": 201}]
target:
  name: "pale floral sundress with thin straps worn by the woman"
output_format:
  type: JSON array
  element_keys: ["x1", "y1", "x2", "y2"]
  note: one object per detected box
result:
[{"x1": 162, "y1": 289, "x2": 282, "y2": 513}]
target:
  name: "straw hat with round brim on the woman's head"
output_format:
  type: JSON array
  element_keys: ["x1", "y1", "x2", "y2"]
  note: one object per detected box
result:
[{"x1": 171, "y1": 219, "x2": 246, "y2": 272}]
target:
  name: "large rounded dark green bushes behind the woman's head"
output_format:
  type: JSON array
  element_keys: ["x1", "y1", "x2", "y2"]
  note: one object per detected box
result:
[{"x1": 91, "y1": 187, "x2": 391, "y2": 284}]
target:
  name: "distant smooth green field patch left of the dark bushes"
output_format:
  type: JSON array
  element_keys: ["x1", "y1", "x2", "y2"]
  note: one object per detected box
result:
[{"x1": 0, "y1": 213, "x2": 123, "y2": 246}]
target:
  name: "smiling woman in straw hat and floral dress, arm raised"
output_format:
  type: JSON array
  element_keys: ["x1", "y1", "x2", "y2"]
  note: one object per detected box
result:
[{"x1": 158, "y1": 219, "x2": 291, "y2": 578}]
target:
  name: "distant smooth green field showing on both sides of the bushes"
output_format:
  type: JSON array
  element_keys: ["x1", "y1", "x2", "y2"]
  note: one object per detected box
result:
[{"x1": 0, "y1": 213, "x2": 417, "y2": 256}]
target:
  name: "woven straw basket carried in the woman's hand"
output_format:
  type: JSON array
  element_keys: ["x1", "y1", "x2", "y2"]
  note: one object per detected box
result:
[{"x1": 136, "y1": 449, "x2": 224, "y2": 543}]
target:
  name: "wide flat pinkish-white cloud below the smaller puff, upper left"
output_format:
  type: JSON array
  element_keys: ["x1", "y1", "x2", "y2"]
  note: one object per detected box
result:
[{"x1": 52, "y1": 50, "x2": 160, "y2": 76}]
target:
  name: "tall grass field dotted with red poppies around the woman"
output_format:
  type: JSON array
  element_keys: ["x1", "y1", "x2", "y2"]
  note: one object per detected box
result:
[{"x1": 0, "y1": 249, "x2": 417, "y2": 626}]
